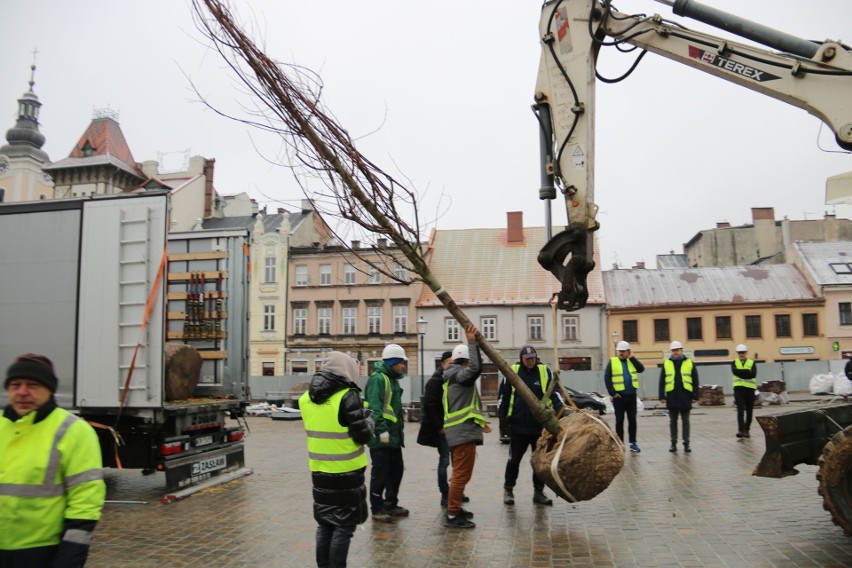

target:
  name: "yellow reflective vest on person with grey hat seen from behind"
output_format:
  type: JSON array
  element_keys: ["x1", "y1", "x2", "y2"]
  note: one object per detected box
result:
[{"x1": 299, "y1": 388, "x2": 367, "y2": 473}]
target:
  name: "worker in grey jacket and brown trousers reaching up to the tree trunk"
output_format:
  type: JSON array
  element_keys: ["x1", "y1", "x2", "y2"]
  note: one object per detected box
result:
[{"x1": 444, "y1": 324, "x2": 489, "y2": 529}]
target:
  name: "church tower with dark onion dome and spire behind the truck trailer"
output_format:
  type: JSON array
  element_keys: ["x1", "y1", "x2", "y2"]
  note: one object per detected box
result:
[{"x1": 0, "y1": 57, "x2": 54, "y2": 202}]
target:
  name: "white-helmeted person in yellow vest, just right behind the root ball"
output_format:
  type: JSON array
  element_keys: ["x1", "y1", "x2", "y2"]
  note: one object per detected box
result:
[{"x1": 604, "y1": 341, "x2": 645, "y2": 453}]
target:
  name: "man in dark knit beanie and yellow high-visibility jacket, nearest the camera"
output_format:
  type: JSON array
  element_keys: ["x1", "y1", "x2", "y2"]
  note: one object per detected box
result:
[{"x1": 0, "y1": 353, "x2": 106, "y2": 568}]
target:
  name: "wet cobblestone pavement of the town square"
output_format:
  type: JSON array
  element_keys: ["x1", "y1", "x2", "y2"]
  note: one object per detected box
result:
[{"x1": 88, "y1": 399, "x2": 852, "y2": 568}]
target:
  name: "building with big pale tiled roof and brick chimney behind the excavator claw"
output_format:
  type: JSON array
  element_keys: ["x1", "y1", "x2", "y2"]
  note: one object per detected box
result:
[{"x1": 417, "y1": 212, "x2": 606, "y2": 396}]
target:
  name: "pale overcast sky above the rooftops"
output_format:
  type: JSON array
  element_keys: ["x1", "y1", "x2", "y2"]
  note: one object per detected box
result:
[{"x1": 0, "y1": 0, "x2": 852, "y2": 269}]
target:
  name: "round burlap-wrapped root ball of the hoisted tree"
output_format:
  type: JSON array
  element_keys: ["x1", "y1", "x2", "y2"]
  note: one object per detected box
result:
[{"x1": 532, "y1": 411, "x2": 624, "y2": 503}]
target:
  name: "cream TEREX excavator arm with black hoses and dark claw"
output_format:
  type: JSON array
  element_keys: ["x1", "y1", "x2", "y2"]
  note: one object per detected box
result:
[{"x1": 533, "y1": 0, "x2": 852, "y2": 310}]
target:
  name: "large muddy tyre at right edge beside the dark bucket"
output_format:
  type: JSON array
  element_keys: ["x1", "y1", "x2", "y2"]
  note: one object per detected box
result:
[{"x1": 817, "y1": 426, "x2": 852, "y2": 536}]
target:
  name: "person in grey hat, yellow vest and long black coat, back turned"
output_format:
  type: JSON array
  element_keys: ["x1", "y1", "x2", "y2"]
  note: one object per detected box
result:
[{"x1": 299, "y1": 351, "x2": 374, "y2": 566}]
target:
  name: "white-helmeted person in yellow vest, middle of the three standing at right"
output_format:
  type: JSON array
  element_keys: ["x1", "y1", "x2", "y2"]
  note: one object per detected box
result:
[{"x1": 660, "y1": 341, "x2": 698, "y2": 453}]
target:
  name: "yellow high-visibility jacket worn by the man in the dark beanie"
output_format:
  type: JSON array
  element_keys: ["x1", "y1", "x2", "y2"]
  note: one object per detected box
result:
[{"x1": 0, "y1": 408, "x2": 106, "y2": 550}]
